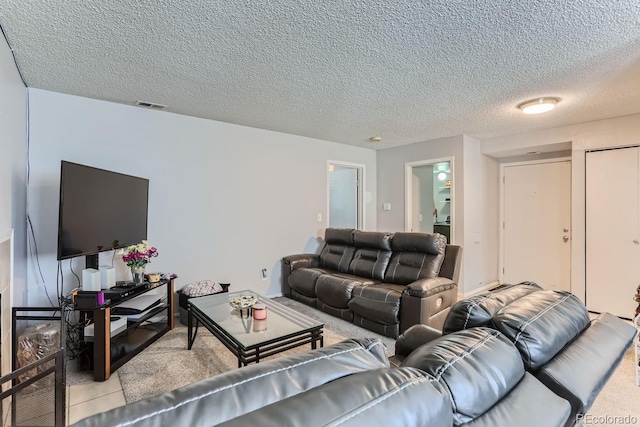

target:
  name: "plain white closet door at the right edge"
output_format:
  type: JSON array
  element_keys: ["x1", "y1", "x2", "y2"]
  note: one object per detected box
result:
[{"x1": 586, "y1": 147, "x2": 640, "y2": 318}]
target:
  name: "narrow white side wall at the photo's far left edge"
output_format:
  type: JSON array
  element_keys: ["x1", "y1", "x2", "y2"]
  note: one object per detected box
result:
[{"x1": 0, "y1": 33, "x2": 27, "y2": 308}]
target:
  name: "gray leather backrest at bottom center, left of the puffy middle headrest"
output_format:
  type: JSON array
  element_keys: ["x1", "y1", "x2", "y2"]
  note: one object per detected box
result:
[{"x1": 222, "y1": 368, "x2": 453, "y2": 427}]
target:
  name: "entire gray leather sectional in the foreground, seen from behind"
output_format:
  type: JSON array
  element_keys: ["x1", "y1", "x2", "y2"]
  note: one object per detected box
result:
[{"x1": 74, "y1": 286, "x2": 635, "y2": 427}]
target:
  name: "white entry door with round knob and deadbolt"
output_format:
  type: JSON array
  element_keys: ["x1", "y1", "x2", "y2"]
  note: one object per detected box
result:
[{"x1": 502, "y1": 160, "x2": 571, "y2": 291}]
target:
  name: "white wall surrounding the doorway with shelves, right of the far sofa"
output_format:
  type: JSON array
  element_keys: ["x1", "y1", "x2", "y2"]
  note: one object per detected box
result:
[{"x1": 377, "y1": 136, "x2": 499, "y2": 295}]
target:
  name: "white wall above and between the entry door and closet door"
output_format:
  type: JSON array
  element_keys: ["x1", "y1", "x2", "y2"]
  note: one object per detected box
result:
[{"x1": 481, "y1": 114, "x2": 640, "y2": 299}]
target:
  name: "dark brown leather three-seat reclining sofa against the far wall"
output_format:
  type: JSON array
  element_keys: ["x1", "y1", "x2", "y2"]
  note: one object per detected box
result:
[{"x1": 282, "y1": 228, "x2": 462, "y2": 338}]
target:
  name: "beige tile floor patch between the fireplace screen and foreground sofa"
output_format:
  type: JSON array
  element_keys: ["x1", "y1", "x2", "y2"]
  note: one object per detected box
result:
[{"x1": 67, "y1": 372, "x2": 126, "y2": 425}]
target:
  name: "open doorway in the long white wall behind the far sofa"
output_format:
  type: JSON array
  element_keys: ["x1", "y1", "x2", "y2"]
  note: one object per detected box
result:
[{"x1": 327, "y1": 161, "x2": 364, "y2": 230}]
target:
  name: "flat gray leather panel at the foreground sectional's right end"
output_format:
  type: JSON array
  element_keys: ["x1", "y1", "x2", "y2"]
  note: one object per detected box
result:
[{"x1": 536, "y1": 313, "x2": 636, "y2": 419}]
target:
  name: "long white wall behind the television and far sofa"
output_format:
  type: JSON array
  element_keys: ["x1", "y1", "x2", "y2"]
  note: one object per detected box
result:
[{"x1": 29, "y1": 89, "x2": 376, "y2": 302}]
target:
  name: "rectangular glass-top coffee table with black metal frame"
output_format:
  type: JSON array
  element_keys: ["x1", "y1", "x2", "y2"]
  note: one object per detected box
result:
[{"x1": 187, "y1": 291, "x2": 324, "y2": 367}]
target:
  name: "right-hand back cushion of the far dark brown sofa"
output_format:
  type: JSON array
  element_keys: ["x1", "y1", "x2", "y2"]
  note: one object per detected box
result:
[{"x1": 384, "y1": 233, "x2": 447, "y2": 285}]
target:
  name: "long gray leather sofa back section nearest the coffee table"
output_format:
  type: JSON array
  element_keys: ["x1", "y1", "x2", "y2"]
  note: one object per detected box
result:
[{"x1": 76, "y1": 339, "x2": 389, "y2": 427}]
